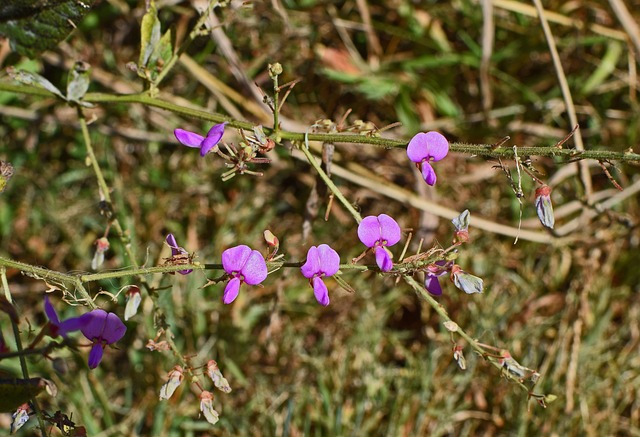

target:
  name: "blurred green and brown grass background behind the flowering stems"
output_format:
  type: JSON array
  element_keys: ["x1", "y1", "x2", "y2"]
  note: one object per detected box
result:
[{"x1": 0, "y1": 0, "x2": 640, "y2": 436}]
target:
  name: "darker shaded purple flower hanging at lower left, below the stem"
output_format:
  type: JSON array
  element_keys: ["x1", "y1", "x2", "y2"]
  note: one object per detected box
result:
[{"x1": 80, "y1": 309, "x2": 127, "y2": 369}]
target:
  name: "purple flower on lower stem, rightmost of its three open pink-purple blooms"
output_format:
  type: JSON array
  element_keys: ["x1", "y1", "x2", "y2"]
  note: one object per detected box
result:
[{"x1": 358, "y1": 214, "x2": 400, "y2": 272}]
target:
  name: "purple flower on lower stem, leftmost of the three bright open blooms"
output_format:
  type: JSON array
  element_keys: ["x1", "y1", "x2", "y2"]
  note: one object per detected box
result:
[{"x1": 222, "y1": 244, "x2": 268, "y2": 304}]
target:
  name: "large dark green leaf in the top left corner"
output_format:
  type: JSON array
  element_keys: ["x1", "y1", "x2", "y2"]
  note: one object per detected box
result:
[{"x1": 0, "y1": 0, "x2": 94, "y2": 58}]
